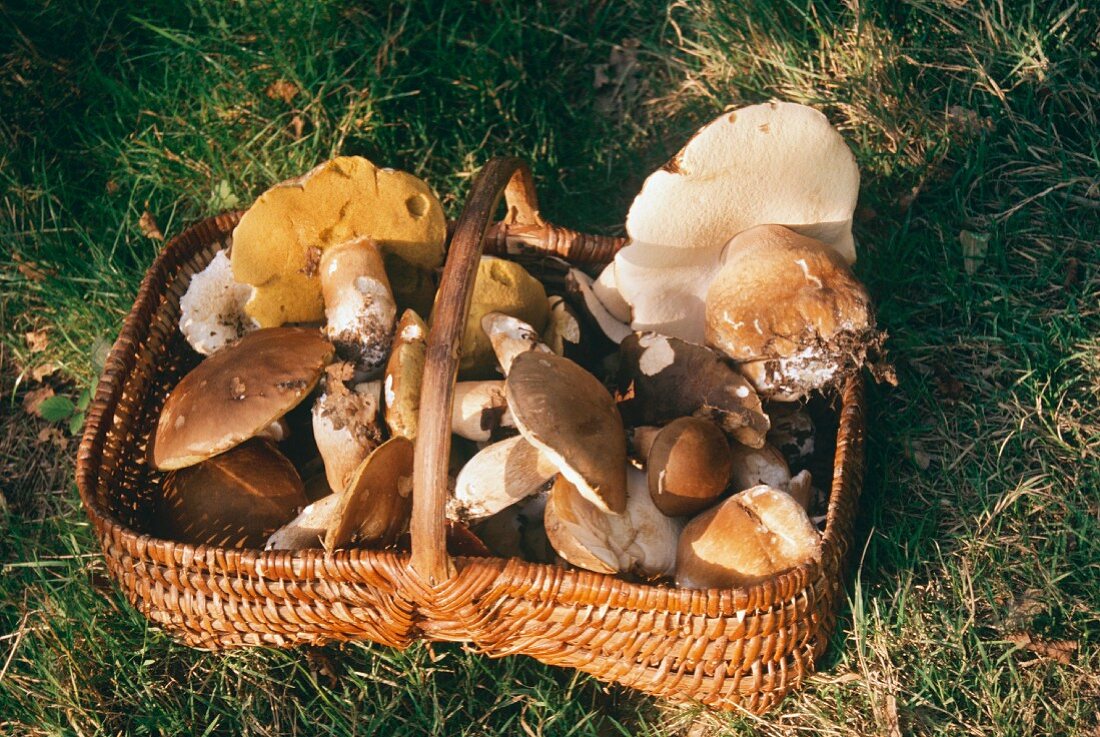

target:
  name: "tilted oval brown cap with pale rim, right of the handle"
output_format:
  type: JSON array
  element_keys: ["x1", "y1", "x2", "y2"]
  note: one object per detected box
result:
[{"x1": 504, "y1": 352, "x2": 627, "y2": 514}]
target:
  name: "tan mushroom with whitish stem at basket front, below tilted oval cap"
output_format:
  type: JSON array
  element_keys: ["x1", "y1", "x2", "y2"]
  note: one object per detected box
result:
[{"x1": 543, "y1": 468, "x2": 682, "y2": 578}]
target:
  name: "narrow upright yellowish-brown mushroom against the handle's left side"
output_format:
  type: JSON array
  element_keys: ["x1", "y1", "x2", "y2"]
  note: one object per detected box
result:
[{"x1": 383, "y1": 310, "x2": 428, "y2": 440}]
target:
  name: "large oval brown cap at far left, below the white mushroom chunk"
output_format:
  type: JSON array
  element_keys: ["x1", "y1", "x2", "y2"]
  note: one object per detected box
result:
[{"x1": 152, "y1": 328, "x2": 333, "y2": 471}]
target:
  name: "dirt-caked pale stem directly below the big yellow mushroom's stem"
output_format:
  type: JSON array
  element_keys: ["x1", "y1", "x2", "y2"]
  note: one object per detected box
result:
[{"x1": 314, "y1": 363, "x2": 383, "y2": 493}]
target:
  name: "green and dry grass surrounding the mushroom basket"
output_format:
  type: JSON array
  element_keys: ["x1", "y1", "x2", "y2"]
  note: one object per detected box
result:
[{"x1": 0, "y1": 0, "x2": 1100, "y2": 737}]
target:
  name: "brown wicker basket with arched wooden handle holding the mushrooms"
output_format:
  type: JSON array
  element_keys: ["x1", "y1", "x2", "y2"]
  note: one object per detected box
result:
[{"x1": 77, "y1": 158, "x2": 864, "y2": 713}]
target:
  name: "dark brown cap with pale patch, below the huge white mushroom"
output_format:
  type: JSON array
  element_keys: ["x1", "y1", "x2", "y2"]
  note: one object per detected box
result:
[{"x1": 618, "y1": 333, "x2": 768, "y2": 448}]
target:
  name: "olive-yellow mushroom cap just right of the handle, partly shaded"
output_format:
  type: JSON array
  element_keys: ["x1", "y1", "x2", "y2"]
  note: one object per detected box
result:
[{"x1": 444, "y1": 256, "x2": 547, "y2": 378}]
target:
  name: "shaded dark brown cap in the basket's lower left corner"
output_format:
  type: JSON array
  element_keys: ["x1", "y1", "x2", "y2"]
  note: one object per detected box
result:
[{"x1": 155, "y1": 440, "x2": 308, "y2": 548}]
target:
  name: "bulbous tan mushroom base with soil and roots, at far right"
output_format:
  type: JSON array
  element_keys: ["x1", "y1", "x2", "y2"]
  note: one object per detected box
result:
[{"x1": 706, "y1": 226, "x2": 882, "y2": 402}]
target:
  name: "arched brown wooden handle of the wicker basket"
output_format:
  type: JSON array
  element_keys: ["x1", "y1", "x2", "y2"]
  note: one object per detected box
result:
[{"x1": 409, "y1": 156, "x2": 541, "y2": 585}]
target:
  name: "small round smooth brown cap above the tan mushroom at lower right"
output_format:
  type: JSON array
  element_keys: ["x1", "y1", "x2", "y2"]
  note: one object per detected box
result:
[{"x1": 646, "y1": 417, "x2": 732, "y2": 517}]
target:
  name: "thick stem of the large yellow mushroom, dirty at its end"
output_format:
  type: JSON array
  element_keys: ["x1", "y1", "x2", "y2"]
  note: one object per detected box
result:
[{"x1": 320, "y1": 237, "x2": 397, "y2": 376}]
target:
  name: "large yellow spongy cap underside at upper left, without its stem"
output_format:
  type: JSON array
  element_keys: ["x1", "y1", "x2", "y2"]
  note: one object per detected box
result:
[{"x1": 230, "y1": 156, "x2": 447, "y2": 327}]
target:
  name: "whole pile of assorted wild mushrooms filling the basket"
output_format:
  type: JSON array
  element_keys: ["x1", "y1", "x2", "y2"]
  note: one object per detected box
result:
[{"x1": 150, "y1": 103, "x2": 881, "y2": 587}]
